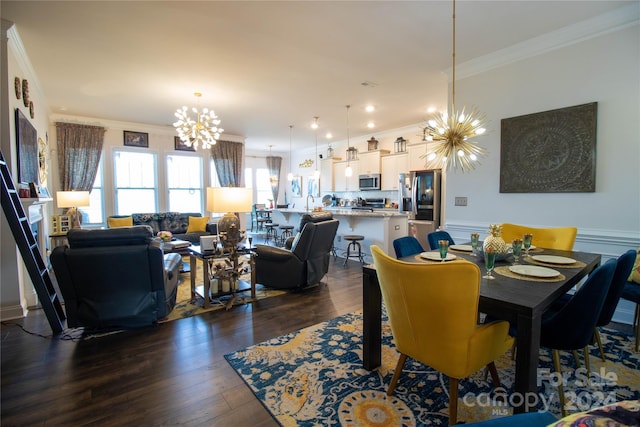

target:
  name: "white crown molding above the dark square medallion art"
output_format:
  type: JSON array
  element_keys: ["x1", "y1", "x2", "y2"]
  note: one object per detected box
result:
[{"x1": 452, "y1": 2, "x2": 640, "y2": 81}]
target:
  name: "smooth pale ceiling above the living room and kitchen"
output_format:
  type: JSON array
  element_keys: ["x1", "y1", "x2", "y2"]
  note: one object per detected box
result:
[{"x1": 1, "y1": 0, "x2": 637, "y2": 151}]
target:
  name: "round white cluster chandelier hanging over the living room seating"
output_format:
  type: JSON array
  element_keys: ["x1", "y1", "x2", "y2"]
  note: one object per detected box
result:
[{"x1": 173, "y1": 92, "x2": 224, "y2": 150}]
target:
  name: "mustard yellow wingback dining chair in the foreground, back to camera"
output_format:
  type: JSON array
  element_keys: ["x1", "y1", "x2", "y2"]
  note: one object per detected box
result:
[{"x1": 371, "y1": 245, "x2": 513, "y2": 425}]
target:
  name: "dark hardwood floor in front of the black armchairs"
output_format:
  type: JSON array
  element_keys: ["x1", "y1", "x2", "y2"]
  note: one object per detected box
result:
[{"x1": 0, "y1": 241, "x2": 362, "y2": 427}]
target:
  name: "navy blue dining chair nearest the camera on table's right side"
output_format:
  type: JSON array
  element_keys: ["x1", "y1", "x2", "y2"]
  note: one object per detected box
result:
[{"x1": 540, "y1": 259, "x2": 617, "y2": 417}]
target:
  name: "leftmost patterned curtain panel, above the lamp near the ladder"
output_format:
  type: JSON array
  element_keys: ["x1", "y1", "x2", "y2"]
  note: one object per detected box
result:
[{"x1": 56, "y1": 122, "x2": 105, "y2": 191}]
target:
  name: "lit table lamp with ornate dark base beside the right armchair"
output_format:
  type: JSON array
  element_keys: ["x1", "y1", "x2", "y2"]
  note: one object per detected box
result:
[{"x1": 207, "y1": 187, "x2": 253, "y2": 246}]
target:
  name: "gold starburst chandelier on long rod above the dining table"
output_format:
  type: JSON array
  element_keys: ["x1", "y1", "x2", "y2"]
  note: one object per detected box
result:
[{"x1": 420, "y1": 0, "x2": 486, "y2": 172}]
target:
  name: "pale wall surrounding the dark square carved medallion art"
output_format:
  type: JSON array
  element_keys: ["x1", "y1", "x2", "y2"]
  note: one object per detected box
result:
[{"x1": 445, "y1": 22, "x2": 640, "y2": 322}]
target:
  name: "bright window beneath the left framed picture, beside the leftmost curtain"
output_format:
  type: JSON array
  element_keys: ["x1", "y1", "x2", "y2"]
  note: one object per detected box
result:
[{"x1": 113, "y1": 151, "x2": 158, "y2": 215}]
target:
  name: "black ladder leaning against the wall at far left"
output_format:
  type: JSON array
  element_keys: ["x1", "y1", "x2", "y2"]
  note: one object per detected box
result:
[{"x1": 0, "y1": 150, "x2": 66, "y2": 334}]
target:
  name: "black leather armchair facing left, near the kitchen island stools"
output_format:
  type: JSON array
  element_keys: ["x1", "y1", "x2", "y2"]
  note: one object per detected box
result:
[{"x1": 255, "y1": 213, "x2": 339, "y2": 289}]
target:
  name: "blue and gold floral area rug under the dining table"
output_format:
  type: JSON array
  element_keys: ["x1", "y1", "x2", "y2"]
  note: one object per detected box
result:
[{"x1": 225, "y1": 312, "x2": 640, "y2": 427}]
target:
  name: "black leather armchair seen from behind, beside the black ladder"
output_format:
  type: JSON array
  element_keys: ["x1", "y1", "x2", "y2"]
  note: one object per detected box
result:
[{"x1": 50, "y1": 225, "x2": 182, "y2": 329}]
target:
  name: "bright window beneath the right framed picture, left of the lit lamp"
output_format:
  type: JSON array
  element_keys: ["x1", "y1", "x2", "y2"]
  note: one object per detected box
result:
[{"x1": 167, "y1": 154, "x2": 203, "y2": 212}]
